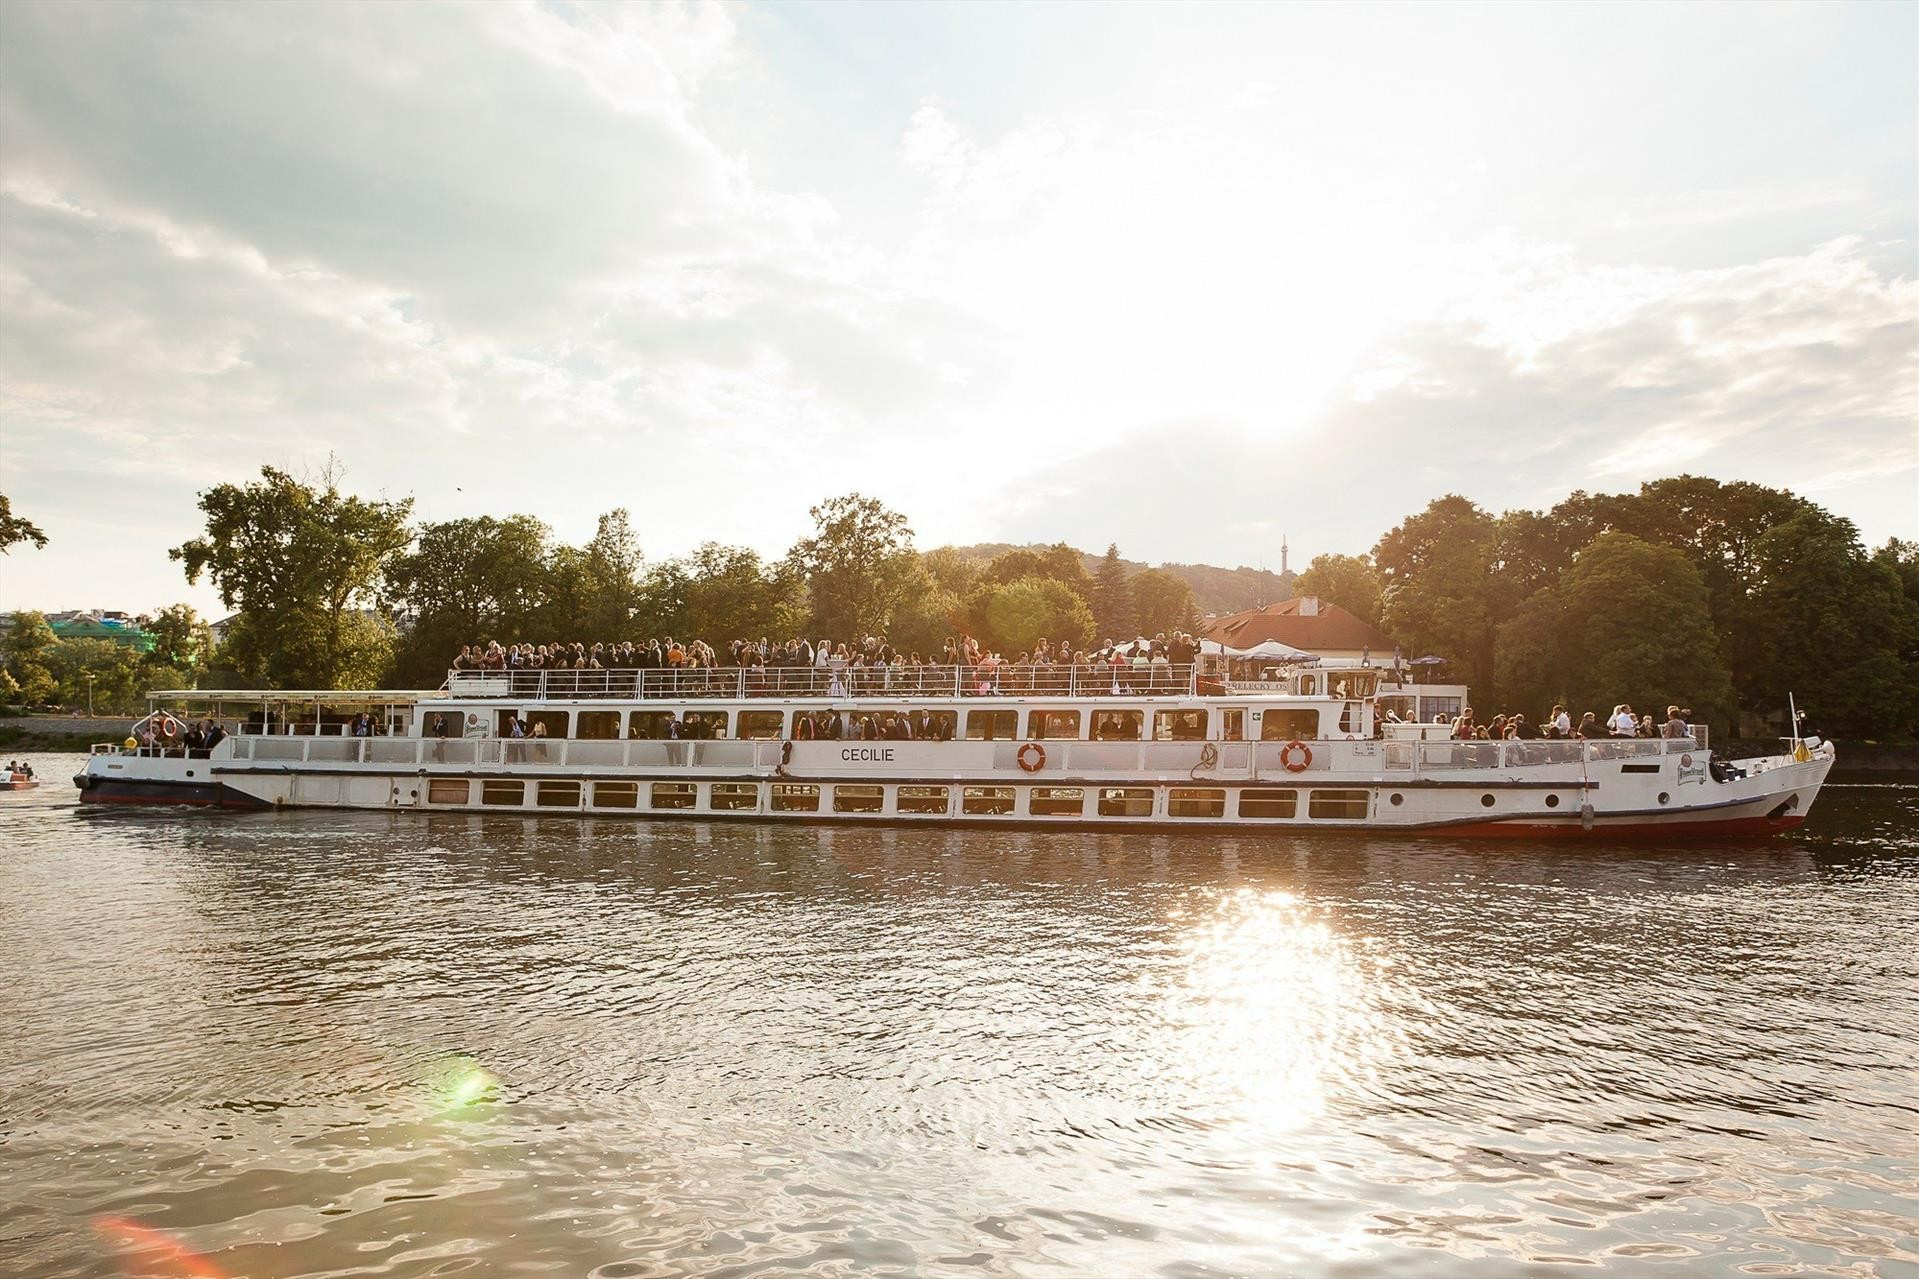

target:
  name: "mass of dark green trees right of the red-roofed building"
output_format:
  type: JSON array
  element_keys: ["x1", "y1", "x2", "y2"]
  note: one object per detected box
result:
[{"x1": 1297, "y1": 476, "x2": 1919, "y2": 739}]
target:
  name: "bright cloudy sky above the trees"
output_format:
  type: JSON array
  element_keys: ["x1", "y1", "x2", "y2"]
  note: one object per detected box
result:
[{"x1": 0, "y1": 2, "x2": 1919, "y2": 609}]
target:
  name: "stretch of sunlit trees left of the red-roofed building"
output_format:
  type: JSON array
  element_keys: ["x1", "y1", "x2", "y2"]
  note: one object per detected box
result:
[{"x1": 0, "y1": 467, "x2": 1197, "y2": 709}]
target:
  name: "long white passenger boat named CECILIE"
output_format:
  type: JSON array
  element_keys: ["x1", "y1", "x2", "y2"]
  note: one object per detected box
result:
[{"x1": 75, "y1": 659, "x2": 1835, "y2": 837}]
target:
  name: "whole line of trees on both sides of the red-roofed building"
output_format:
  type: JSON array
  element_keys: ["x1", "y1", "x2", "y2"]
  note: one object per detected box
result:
[{"x1": 0, "y1": 467, "x2": 1919, "y2": 739}]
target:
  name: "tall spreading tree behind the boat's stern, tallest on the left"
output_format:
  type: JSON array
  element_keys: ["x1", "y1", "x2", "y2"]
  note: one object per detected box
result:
[{"x1": 169, "y1": 467, "x2": 413, "y2": 688}]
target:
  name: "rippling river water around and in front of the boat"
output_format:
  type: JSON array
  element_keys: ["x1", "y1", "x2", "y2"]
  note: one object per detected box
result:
[{"x1": 0, "y1": 757, "x2": 1919, "y2": 1279}]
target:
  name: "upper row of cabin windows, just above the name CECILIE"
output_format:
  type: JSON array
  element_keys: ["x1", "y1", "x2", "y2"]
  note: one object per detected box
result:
[{"x1": 464, "y1": 707, "x2": 1353, "y2": 741}]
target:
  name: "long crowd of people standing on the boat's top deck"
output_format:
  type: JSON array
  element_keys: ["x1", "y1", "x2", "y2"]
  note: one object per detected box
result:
[{"x1": 453, "y1": 630, "x2": 1199, "y2": 697}]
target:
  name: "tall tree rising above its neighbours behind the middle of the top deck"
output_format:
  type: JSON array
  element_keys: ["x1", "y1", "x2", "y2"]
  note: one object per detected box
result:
[{"x1": 787, "y1": 494, "x2": 919, "y2": 643}]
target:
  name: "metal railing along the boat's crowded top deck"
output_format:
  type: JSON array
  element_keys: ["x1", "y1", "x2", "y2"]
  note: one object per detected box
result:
[{"x1": 445, "y1": 663, "x2": 1224, "y2": 701}]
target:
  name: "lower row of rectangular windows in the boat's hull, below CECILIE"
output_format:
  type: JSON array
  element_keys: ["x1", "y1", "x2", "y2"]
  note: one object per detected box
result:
[{"x1": 426, "y1": 778, "x2": 1368, "y2": 820}]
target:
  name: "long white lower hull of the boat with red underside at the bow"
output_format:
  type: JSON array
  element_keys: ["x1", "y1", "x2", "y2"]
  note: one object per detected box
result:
[{"x1": 77, "y1": 743, "x2": 1833, "y2": 839}]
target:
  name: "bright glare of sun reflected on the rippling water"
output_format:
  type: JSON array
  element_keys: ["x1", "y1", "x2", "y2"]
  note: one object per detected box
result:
[{"x1": 1159, "y1": 889, "x2": 1403, "y2": 1133}]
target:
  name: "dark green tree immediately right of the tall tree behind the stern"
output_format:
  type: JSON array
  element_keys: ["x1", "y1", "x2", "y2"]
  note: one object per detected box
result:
[{"x1": 380, "y1": 515, "x2": 552, "y2": 688}]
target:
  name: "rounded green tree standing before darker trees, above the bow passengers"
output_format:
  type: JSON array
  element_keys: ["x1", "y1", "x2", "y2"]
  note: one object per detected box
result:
[{"x1": 1497, "y1": 532, "x2": 1733, "y2": 720}]
